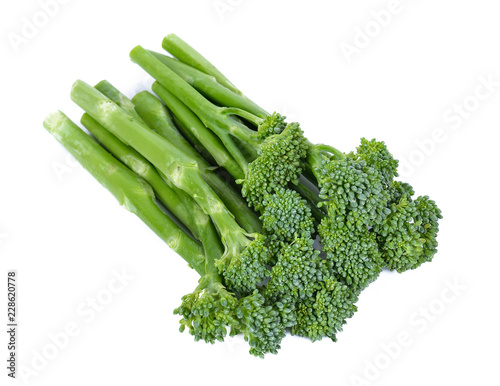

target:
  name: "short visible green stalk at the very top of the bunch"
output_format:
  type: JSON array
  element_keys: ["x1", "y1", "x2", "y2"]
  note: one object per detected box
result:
[{"x1": 162, "y1": 34, "x2": 242, "y2": 95}]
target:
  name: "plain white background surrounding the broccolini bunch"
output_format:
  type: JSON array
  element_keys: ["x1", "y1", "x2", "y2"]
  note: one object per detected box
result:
[{"x1": 0, "y1": 0, "x2": 500, "y2": 386}]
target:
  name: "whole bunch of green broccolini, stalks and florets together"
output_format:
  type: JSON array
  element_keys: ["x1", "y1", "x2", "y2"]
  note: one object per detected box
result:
[{"x1": 44, "y1": 35, "x2": 442, "y2": 357}]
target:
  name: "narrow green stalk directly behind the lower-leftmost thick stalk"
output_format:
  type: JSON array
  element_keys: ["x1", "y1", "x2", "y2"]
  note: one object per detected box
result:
[{"x1": 80, "y1": 113, "x2": 199, "y2": 239}]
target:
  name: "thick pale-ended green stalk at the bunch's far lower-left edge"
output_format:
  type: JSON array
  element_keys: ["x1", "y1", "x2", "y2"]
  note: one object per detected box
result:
[{"x1": 43, "y1": 110, "x2": 205, "y2": 275}]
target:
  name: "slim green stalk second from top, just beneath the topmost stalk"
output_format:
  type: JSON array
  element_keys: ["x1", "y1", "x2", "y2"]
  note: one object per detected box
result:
[{"x1": 149, "y1": 51, "x2": 269, "y2": 118}]
